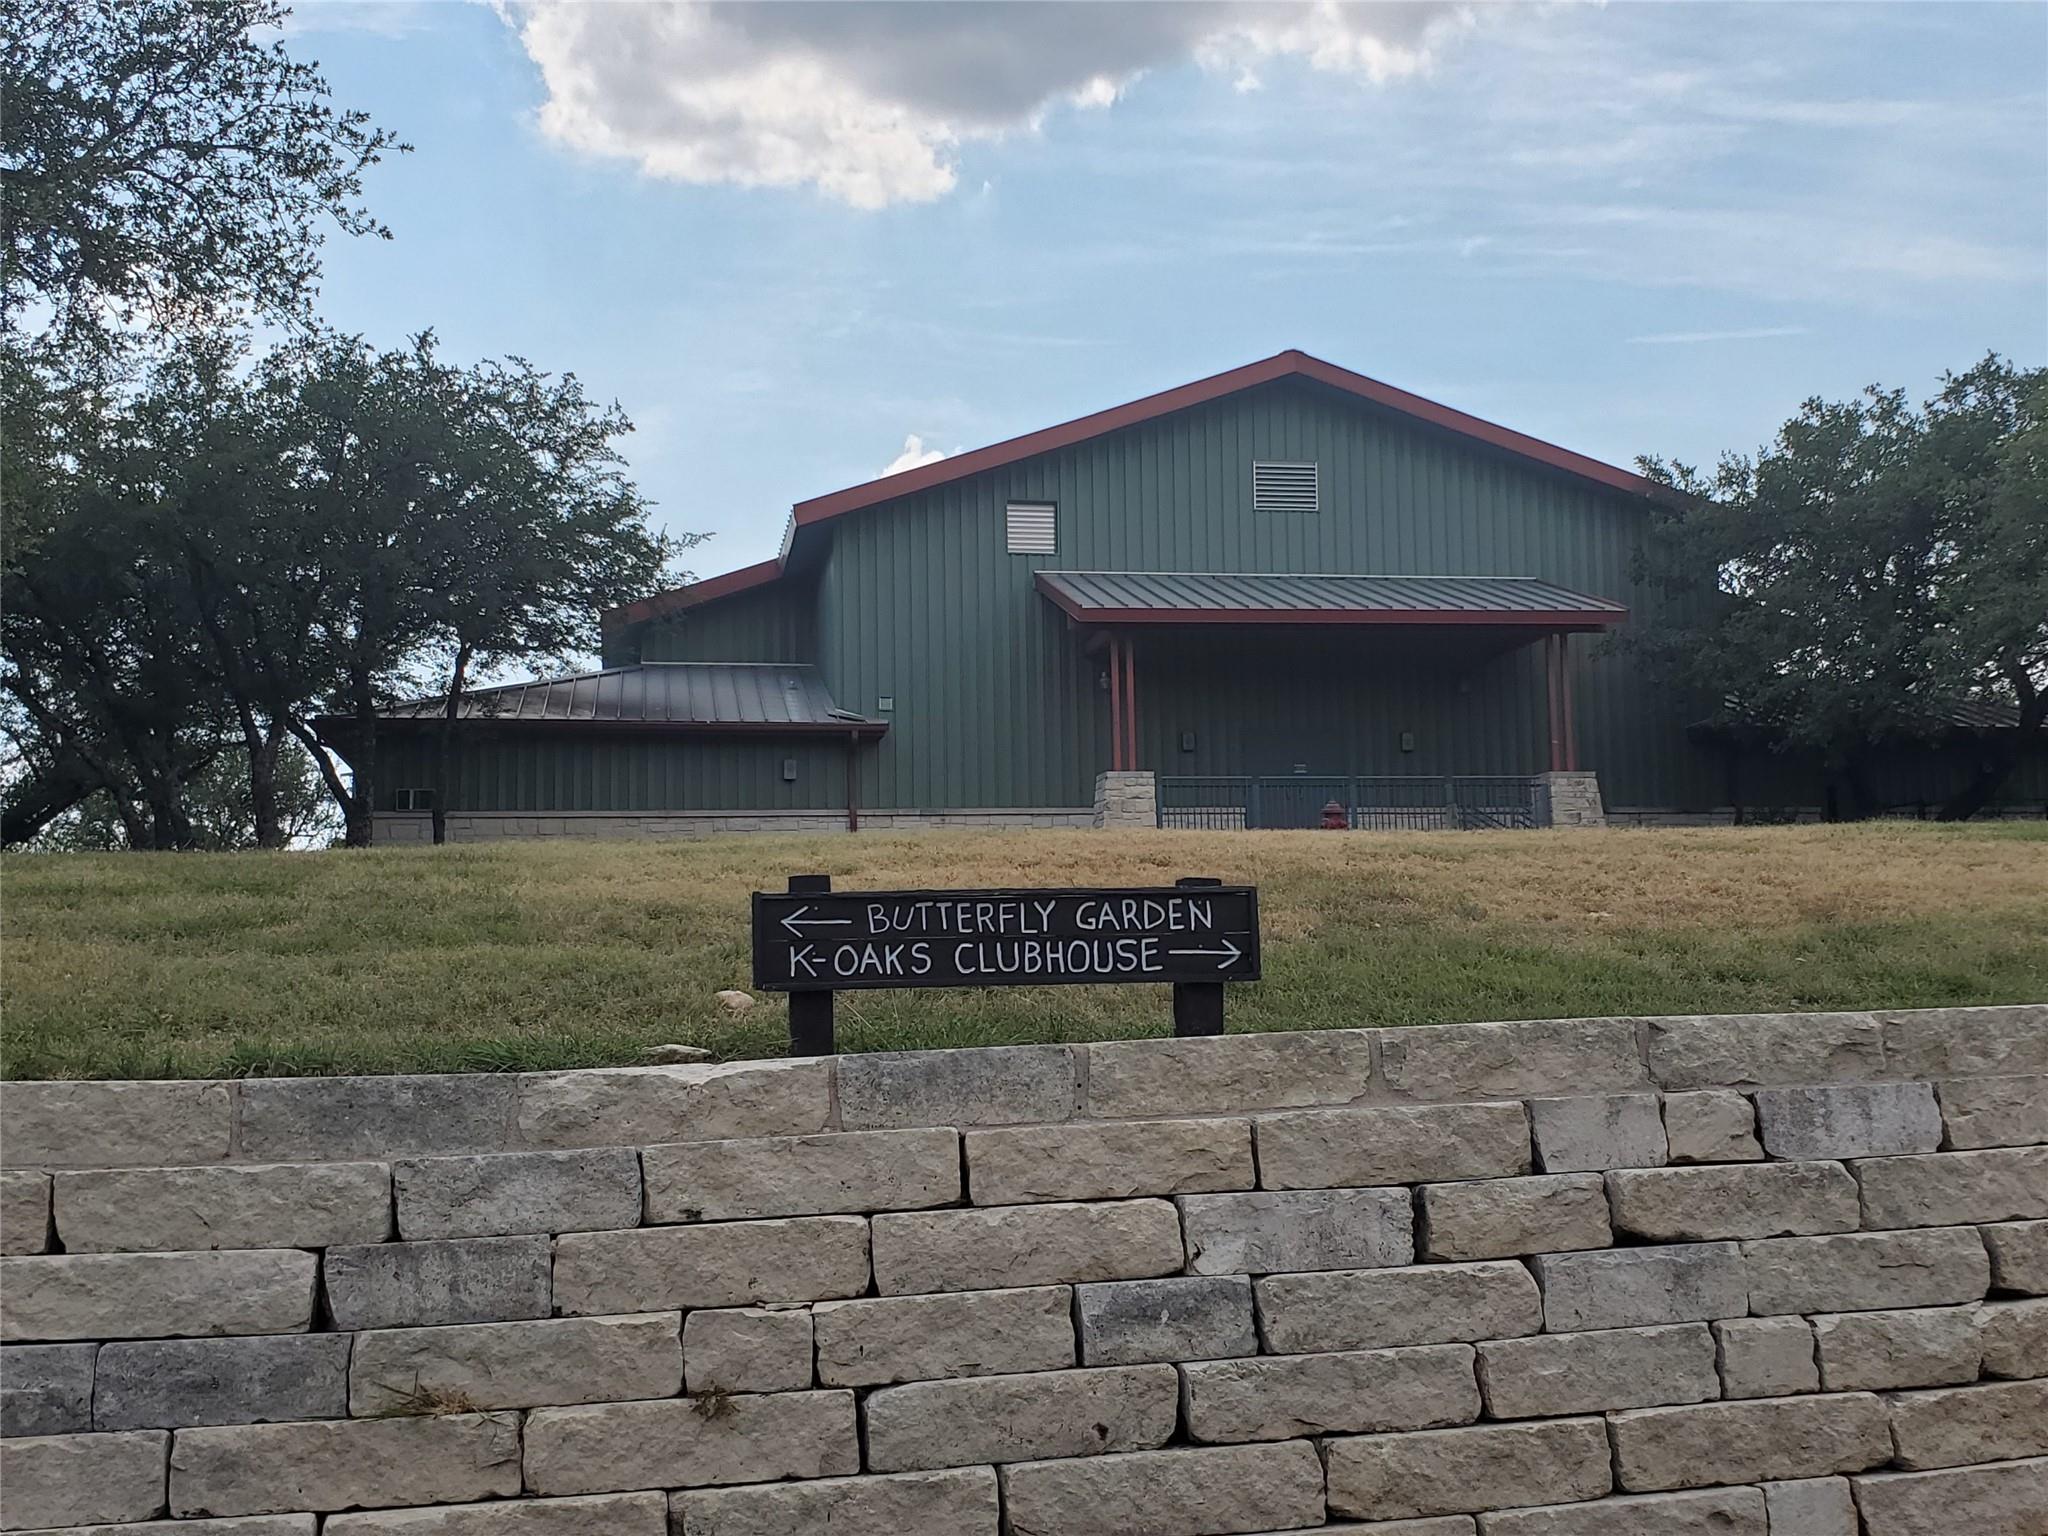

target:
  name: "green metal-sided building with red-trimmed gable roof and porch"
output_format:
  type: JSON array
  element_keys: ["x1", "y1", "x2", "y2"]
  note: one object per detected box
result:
[{"x1": 379, "y1": 352, "x2": 2048, "y2": 840}]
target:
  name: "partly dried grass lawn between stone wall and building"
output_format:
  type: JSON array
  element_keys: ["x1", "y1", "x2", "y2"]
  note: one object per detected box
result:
[{"x1": 0, "y1": 823, "x2": 2048, "y2": 1077}]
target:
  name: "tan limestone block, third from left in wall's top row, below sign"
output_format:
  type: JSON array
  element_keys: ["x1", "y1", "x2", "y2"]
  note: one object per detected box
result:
[{"x1": 518, "y1": 1059, "x2": 831, "y2": 1149}]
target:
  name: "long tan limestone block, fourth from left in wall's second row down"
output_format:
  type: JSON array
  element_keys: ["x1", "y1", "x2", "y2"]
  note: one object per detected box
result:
[{"x1": 643, "y1": 1126, "x2": 961, "y2": 1227}]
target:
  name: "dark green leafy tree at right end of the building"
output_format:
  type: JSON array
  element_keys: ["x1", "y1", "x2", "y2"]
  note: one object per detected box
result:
[{"x1": 1632, "y1": 354, "x2": 2048, "y2": 817}]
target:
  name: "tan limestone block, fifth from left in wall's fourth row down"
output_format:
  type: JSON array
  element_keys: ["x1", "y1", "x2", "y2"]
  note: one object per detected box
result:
[{"x1": 811, "y1": 1286, "x2": 1073, "y2": 1386}]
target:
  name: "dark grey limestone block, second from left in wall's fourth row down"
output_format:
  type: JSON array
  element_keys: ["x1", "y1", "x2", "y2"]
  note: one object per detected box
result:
[{"x1": 92, "y1": 1333, "x2": 348, "y2": 1430}]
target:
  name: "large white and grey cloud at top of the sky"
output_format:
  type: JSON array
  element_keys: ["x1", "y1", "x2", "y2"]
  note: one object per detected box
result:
[{"x1": 496, "y1": 0, "x2": 1475, "y2": 209}]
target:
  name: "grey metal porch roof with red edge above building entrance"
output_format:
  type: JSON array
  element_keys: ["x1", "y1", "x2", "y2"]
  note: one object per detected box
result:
[{"x1": 1038, "y1": 571, "x2": 1628, "y2": 629}]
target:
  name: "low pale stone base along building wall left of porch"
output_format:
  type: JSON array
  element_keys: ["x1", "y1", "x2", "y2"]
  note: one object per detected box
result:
[{"x1": 375, "y1": 807, "x2": 1094, "y2": 844}]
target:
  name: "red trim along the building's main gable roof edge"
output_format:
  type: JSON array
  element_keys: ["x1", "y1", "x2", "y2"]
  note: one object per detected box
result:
[{"x1": 604, "y1": 348, "x2": 1667, "y2": 625}]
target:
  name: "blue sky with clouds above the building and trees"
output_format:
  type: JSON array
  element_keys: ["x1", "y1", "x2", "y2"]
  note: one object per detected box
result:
[{"x1": 287, "y1": 0, "x2": 2048, "y2": 575}]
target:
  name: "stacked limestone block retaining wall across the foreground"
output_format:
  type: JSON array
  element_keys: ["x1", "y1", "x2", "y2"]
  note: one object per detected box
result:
[{"x1": 0, "y1": 1008, "x2": 2048, "y2": 1536}]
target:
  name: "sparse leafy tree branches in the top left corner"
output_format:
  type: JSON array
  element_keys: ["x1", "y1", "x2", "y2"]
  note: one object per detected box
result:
[{"x1": 0, "y1": 0, "x2": 406, "y2": 354}]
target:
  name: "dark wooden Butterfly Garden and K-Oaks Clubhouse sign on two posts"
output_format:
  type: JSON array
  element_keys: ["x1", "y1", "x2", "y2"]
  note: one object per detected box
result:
[{"x1": 754, "y1": 874, "x2": 1260, "y2": 1057}]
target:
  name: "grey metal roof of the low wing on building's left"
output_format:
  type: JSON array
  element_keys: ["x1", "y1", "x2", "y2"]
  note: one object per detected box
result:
[{"x1": 383, "y1": 662, "x2": 887, "y2": 735}]
